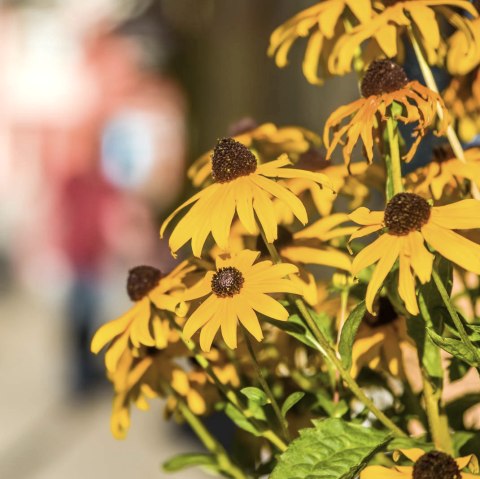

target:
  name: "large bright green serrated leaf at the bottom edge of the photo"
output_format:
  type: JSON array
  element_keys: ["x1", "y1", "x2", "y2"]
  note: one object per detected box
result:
[{"x1": 270, "y1": 418, "x2": 391, "y2": 479}]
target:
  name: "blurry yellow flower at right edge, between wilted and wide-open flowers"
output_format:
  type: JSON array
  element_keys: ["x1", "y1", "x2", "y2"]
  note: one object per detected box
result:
[{"x1": 406, "y1": 146, "x2": 480, "y2": 200}]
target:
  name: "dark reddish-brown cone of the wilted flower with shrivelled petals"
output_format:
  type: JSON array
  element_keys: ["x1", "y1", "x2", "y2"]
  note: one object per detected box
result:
[{"x1": 360, "y1": 60, "x2": 408, "y2": 98}]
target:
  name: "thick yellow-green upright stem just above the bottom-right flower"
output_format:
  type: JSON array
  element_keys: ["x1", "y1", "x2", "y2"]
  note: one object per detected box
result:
[{"x1": 422, "y1": 370, "x2": 453, "y2": 455}]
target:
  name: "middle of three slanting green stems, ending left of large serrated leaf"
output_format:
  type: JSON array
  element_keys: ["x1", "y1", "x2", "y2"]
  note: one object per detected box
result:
[{"x1": 163, "y1": 317, "x2": 287, "y2": 452}]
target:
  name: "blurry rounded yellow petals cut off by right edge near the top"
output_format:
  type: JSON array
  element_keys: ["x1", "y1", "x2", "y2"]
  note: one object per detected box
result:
[{"x1": 447, "y1": 18, "x2": 480, "y2": 75}]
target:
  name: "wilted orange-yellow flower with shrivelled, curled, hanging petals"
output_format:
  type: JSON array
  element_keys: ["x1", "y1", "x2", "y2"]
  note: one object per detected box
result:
[{"x1": 323, "y1": 60, "x2": 449, "y2": 164}]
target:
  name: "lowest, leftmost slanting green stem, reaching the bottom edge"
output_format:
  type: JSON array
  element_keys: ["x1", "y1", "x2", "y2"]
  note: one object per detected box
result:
[{"x1": 162, "y1": 382, "x2": 248, "y2": 479}]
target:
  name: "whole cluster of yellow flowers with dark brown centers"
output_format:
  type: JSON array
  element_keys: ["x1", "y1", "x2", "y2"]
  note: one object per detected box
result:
[{"x1": 92, "y1": 0, "x2": 480, "y2": 479}]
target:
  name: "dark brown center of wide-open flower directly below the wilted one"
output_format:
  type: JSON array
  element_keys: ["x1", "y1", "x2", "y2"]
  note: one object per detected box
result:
[{"x1": 385, "y1": 193, "x2": 431, "y2": 236}]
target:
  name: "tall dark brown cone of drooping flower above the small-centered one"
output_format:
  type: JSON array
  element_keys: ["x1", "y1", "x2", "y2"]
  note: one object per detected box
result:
[{"x1": 212, "y1": 138, "x2": 257, "y2": 183}]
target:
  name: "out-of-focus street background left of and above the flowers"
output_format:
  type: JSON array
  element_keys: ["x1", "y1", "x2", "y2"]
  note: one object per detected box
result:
[{"x1": 0, "y1": 0, "x2": 357, "y2": 479}]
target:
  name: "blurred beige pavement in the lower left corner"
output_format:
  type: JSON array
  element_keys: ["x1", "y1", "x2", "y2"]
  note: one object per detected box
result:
[{"x1": 0, "y1": 291, "x2": 208, "y2": 479}]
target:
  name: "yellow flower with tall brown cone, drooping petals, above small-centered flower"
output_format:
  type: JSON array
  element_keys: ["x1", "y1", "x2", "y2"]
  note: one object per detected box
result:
[{"x1": 160, "y1": 138, "x2": 328, "y2": 257}]
